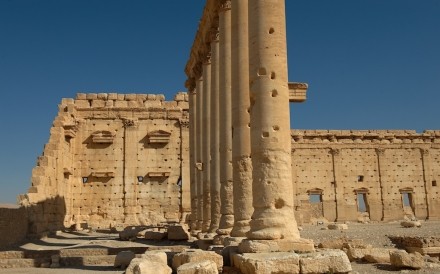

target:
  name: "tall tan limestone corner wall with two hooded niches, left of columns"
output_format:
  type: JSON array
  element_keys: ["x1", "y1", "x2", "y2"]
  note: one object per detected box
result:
[{"x1": 21, "y1": 93, "x2": 190, "y2": 234}]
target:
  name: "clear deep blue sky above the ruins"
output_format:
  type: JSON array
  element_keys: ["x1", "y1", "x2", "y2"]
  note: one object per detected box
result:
[{"x1": 0, "y1": 0, "x2": 440, "y2": 202}]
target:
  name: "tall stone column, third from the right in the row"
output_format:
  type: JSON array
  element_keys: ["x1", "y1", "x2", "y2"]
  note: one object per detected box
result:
[{"x1": 217, "y1": 0, "x2": 234, "y2": 235}]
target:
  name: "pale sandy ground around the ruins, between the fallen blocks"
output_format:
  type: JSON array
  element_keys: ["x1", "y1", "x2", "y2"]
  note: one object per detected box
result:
[{"x1": 0, "y1": 221, "x2": 440, "y2": 274}]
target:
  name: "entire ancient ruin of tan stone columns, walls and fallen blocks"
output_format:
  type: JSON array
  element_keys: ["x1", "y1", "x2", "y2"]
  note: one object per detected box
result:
[{"x1": 0, "y1": 0, "x2": 440, "y2": 273}]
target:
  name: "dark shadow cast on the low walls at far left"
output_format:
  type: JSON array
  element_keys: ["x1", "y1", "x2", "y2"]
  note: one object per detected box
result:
[{"x1": 0, "y1": 196, "x2": 66, "y2": 249}]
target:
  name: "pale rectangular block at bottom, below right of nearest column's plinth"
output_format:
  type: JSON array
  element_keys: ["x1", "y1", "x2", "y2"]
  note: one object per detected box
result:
[{"x1": 299, "y1": 250, "x2": 352, "y2": 274}]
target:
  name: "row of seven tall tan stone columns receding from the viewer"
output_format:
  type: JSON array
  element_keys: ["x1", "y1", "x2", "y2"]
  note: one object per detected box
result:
[{"x1": 187, "y1": 0, "x2": 299, "y2": 248}]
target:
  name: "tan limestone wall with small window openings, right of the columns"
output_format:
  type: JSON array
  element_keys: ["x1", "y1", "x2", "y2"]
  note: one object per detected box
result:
[{"x1": 292, "y1": 130, "x2": 440, "y2": 225}]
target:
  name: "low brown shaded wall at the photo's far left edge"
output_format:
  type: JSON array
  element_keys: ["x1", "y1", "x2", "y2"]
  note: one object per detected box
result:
[{"x1": 0, "y1": 207, "x2": 28, "y2": 248}]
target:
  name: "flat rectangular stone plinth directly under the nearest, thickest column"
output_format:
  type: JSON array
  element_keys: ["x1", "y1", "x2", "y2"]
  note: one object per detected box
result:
[{"x1": 238, "y1": 239, "x2": 315, "y2": 253}]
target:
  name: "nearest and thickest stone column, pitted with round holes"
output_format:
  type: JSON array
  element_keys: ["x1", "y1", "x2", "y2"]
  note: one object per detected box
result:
[{"x1": 241, "y1": 0, "x2": 313, "y2": 252}]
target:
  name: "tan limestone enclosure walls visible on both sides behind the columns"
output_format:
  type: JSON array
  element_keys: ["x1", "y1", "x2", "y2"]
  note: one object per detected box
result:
[{"x1": 20, "y1": 93, "x2": 440, "y2": 235}]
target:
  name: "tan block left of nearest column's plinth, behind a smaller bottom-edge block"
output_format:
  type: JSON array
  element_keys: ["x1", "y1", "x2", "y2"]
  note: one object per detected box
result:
[{"x1": 172, "y1": 249, "x2": 223, "y2": 271}]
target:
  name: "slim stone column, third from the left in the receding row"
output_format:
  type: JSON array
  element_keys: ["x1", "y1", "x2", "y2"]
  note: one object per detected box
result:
[{"x1": 202, "y1": 56, "x2": 211, "y2": 232}]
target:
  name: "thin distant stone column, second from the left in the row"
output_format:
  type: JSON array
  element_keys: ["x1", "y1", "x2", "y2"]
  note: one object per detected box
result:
[{"x1": 195, "y1": 77, "x2": 204, "y2": 231}]
